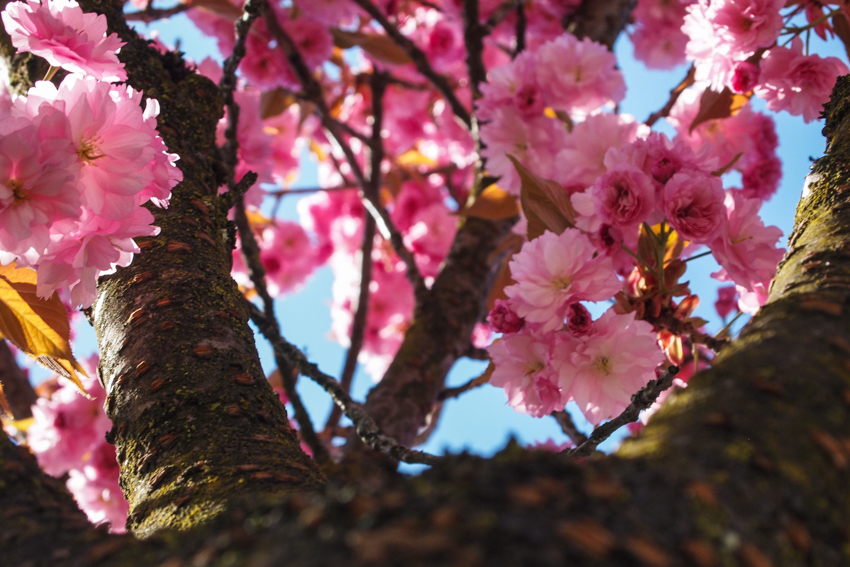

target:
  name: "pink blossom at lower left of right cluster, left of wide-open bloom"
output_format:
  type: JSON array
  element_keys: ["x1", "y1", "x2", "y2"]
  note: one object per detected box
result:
[{"x1": 487, "y1": 332, "x2": 569, "y2": 417}]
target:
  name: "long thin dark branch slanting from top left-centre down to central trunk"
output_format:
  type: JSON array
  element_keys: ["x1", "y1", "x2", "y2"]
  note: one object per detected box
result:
[{"x1": 266, "y1": 11, "x2": 428, "y2": 299}]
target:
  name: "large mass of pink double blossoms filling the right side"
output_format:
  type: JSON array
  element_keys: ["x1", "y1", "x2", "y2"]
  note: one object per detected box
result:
[{"x1": 479, "y1": 0, "x2": 848, "y2": 424}]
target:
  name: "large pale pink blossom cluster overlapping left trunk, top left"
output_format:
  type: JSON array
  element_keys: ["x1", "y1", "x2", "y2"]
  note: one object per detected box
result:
[{"x1": 0, "y1": 0, "x2": 182, "y2": 307}]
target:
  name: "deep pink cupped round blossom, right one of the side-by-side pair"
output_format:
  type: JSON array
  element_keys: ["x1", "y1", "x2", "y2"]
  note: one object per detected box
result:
[{"x1": 661, "y1": 172, "x2": 726, "y2": 243}]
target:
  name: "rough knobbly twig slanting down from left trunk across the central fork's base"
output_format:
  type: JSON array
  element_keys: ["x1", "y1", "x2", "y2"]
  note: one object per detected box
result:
[{"x1": 248, "y1": 302, "x2": 442, "y2": 465}]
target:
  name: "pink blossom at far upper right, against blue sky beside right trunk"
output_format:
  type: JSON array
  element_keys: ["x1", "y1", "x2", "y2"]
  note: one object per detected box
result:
[{"x1": 756, "y1": 37, "x2": 850, "y2": 122}]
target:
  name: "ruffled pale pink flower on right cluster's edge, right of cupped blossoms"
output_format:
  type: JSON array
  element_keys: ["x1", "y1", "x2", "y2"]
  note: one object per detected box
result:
[{"x1": 708, "y1": 191, "x2": 784, "y2": 291}]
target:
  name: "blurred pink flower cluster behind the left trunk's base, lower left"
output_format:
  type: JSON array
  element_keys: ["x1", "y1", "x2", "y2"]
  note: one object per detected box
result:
[{"x1": 27, "y1": 355, "x2": 129, "y2": 533}]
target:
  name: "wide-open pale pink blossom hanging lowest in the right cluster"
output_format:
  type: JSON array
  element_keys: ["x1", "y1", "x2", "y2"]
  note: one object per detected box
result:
[{"x1": 553, "y1": 308, "x2": 665, "y2": 425}]
